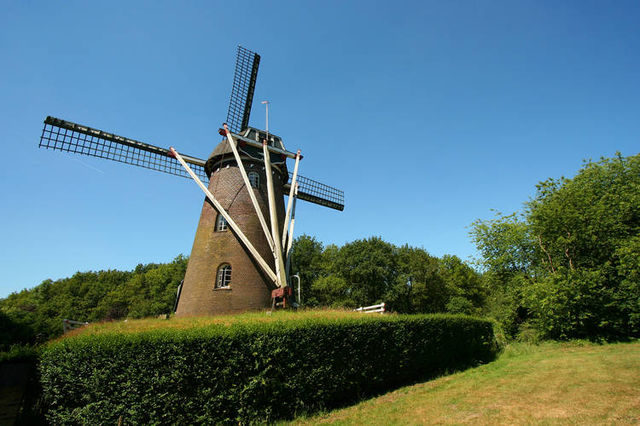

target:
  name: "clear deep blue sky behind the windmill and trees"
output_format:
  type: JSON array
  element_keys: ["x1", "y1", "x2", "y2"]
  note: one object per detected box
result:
[{"x1": 0, "y1": 0, "x2": 640, "y2": 297}]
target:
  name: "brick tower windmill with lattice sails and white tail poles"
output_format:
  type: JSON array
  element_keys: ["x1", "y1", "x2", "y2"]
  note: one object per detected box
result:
[{"x1": 39, "y1": 46, "x2": 344, "y2": 316}]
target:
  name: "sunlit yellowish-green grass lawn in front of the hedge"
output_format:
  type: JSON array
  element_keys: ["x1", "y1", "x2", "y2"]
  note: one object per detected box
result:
[{"x1": 295, "y1": 342, "x2": 640, "y2": 425}]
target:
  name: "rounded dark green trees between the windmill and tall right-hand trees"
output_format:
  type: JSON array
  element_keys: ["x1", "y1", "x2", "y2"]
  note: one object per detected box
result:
[{"x1": 293, "y1": 235, "x2": 485, "y2": 314}]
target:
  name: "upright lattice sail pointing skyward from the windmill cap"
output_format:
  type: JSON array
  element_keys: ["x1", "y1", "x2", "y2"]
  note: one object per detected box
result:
[{"x1": 227, "y1": 46, "x2": 260, "y2": 133}]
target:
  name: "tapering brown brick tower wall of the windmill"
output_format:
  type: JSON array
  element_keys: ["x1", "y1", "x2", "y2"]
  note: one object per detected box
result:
[{"x1": 176, "y1": 146, "x2": 286, "y2": 316}]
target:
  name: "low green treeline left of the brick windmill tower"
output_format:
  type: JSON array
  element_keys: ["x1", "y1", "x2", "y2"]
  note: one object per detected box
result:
[{"x1": 0, "y1": 256, "x2": 187, "y2": 351}]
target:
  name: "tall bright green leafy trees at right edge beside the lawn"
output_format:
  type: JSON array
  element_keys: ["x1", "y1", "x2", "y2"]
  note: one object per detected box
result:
[{"x1": 471, "y1": 154, "x2": 640, "y2": 339}]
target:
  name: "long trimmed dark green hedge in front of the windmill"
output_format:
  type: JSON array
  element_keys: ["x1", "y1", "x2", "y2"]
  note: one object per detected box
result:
[{"x1": 40, "y1": 315, "x2": 498, "y2": 424}]
